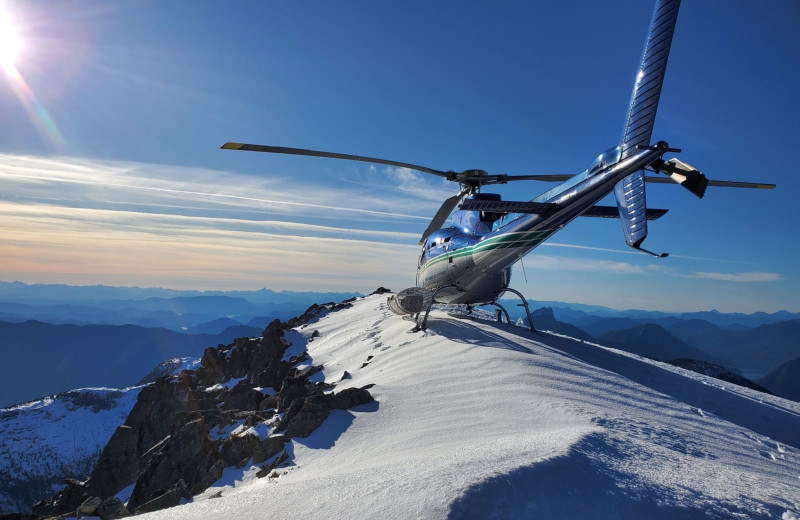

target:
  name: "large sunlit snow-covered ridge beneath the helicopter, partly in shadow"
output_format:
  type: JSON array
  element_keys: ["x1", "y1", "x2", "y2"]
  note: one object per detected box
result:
[{"x1": 119, "y1": 296, "x2": 800, "y2": 520}]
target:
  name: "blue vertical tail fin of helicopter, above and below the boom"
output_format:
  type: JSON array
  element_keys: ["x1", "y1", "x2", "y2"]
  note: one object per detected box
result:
[{"x1": 614, "y1": 0, "x2": 681, "y2": 256}]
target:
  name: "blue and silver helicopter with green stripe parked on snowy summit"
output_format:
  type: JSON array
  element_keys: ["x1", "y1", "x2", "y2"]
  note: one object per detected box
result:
[{"x1": 221, "y1": 0, "x2": 775, "y2": 332}]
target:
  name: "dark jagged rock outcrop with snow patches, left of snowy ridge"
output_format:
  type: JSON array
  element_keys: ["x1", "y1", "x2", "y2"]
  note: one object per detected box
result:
[{"x1": 34, "y1": 303, "x2": 373, "y2": 518}]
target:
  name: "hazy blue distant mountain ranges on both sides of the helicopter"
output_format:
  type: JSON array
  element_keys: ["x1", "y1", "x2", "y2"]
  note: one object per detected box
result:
[{"x1": 0, "y1": 282, "x2": 800, "y2": 406}]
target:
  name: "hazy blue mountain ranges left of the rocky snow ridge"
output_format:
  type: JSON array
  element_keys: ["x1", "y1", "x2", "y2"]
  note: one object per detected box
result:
[{"x1": 0, "y1": 282, "x2": 364, "y2": 407}]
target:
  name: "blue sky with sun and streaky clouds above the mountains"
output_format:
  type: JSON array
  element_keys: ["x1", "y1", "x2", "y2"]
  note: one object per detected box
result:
[{"x1": 0, "y1": 0, "x2": 800, "y2": 312}]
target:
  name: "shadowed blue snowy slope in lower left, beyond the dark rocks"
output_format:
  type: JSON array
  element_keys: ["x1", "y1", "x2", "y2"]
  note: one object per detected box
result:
[{"x1": 0, "y1": 387, "x2": 141, "y2": 511}]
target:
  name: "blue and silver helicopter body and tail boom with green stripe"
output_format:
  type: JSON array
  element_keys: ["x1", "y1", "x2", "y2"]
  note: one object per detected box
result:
[{"x1": 417, "y1": 147, "x2": 665, "y2": 305}]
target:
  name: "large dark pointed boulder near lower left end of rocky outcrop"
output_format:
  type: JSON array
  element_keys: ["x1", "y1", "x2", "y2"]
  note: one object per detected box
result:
[{"x1": 128, "y1": 419, "x2": 220, "y2": 509}]
